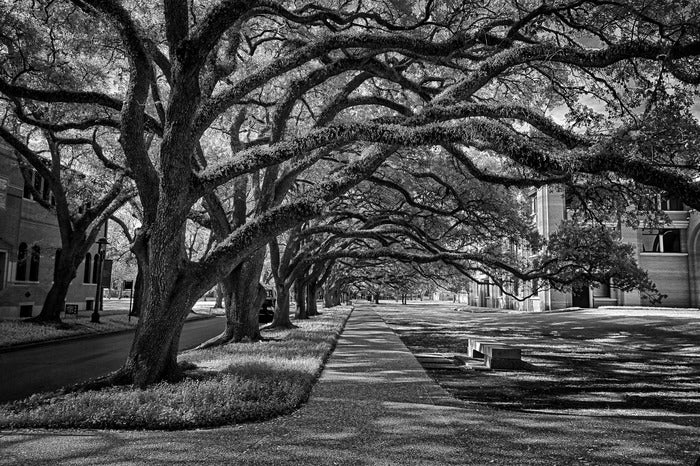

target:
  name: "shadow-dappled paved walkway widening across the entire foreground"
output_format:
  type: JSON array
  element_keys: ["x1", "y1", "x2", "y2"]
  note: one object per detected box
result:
[{"x1": 0, "y1": 304, "x2": 698, "y2": 466}]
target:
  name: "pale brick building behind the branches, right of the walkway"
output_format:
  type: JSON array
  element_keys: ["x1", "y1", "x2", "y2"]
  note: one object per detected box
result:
[{"x1": 468, "y1": 186, "x2": 700, "y2": 310}]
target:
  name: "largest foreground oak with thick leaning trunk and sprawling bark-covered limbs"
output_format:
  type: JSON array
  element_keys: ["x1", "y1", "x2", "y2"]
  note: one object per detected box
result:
[{"x1": 0, "y1": 0, "x2": 700, "y2": 385}]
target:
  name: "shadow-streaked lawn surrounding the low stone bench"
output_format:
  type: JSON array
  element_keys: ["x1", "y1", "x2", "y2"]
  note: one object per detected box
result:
[{"x1": 382, "y1": 307, "x2": 700, "y2": 418}]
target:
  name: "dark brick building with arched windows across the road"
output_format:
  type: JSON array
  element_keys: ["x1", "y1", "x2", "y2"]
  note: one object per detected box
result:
[{"x1": 0, "y1": 140, "x2": 104, "y2": 317}]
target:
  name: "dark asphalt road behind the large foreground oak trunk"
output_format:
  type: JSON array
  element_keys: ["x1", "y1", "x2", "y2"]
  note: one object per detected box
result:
[{"x1": 0, "y1": 317, "x2": 224, "y2": 402}]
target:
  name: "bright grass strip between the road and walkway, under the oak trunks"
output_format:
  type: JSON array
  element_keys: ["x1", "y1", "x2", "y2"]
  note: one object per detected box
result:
[{"x1": 0, "y1": 307, "x2": 351, "y2": 430}]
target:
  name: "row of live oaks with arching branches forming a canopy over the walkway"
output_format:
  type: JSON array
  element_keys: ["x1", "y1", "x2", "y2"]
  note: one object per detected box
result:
[{"x1": 0, "y1": 0, "x2": 700, "y2": 386}]
